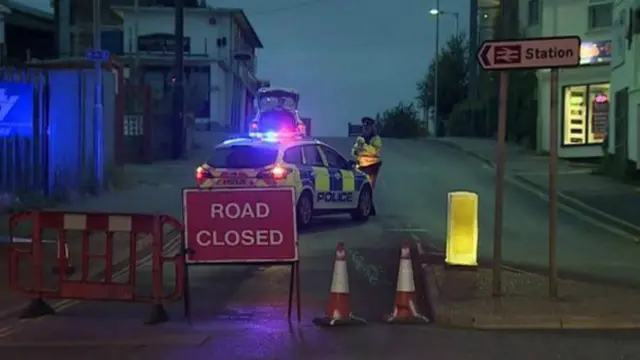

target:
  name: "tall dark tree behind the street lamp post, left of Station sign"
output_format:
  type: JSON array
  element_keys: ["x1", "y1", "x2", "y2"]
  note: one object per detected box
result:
[{"x1": 416, "y1": 34, "x2": 469, "y2": 124}]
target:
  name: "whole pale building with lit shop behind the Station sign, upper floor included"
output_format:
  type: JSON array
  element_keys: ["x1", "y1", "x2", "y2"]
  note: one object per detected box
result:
[{"x1": 519, "y1": 0, "x2": 616, "y2": 158}]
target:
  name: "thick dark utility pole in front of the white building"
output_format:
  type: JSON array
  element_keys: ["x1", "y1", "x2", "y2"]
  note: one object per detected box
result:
[{"x1": 171, "y1": 0, "x2": 186, "y2": 159}]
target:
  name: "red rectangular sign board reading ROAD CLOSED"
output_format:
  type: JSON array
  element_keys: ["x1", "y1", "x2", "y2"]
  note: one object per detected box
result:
[{"x1": 183, "y1": 188, "x2": 298, "y2": 263}]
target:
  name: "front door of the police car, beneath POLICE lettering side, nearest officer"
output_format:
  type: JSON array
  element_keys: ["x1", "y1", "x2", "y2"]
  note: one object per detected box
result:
[{"x1": 320, "y1": 146, "x2": 356, "y2": 209}]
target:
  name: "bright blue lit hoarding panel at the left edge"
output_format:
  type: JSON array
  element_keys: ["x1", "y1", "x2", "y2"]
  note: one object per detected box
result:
[{"x1": 0, "y1": 81, "x2": 33, "y2": 137}]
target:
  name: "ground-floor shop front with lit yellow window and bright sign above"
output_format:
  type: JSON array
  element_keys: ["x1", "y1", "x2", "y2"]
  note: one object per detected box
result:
[{"x1": 538, "y1": 41, "x2": 611, "y2": 158}]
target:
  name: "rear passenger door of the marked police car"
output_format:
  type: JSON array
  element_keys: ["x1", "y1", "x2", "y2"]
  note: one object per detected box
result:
[{"x1": 300, "y1": 144, "x2": 332, "y2": 209}]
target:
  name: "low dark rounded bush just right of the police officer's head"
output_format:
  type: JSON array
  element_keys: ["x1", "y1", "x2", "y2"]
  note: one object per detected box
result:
[{"x1": 376, "y1": 102, "x2": 424, "y2": 138}]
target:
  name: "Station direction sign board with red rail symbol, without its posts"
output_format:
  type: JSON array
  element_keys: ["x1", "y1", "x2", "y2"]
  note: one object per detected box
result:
[{"x1": 476, "y1": 36, "x2": 581, "y2": 70}]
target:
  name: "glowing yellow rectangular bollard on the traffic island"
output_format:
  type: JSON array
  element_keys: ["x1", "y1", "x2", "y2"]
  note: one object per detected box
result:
[{"x1": 445, "y1": 191, "x2": 478, "y2": 266}]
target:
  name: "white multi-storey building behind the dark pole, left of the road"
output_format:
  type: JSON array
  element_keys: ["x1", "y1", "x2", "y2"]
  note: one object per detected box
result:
[{"x1": 114, "y1": 7, "x2": 262, "y2": 131}]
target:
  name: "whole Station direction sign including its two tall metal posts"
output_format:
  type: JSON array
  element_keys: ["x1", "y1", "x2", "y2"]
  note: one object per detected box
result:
[{"x1": 477, "y1": 36, "x2": 581, "y2": 298}]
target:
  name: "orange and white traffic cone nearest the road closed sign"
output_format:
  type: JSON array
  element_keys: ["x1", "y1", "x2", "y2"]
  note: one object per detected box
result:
[{"x1": 313, "y1": 243, "x2": 367, "y2": 326}]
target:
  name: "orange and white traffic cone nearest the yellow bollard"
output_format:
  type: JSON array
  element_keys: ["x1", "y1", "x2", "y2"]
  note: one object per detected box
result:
[{"x1": 387, "y1": 242, "x2": 429, "y2": 324}]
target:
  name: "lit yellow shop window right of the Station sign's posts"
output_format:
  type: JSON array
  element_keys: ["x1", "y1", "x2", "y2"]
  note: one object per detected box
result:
[{"x1": 562, "y1": 84, "x2": 610, "y2": 146}]
